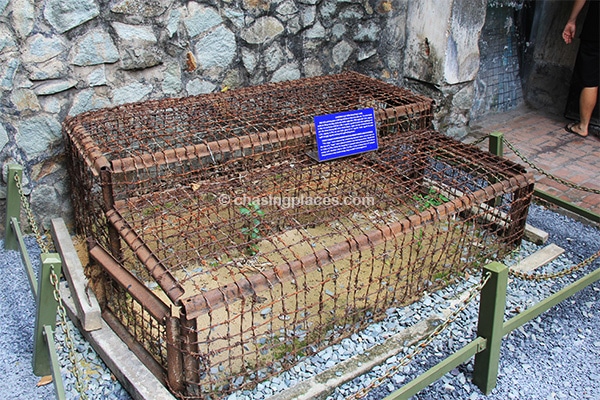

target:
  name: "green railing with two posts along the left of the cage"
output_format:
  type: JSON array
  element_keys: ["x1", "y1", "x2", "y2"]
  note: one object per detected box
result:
[{"x1": 4, "y1": 164, "x2": 66, "y2": 400}]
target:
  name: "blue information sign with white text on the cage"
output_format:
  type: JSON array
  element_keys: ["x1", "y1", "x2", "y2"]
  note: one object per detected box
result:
[{"x1": 315, "y1": 108, "x2": 378, "y2": 161}]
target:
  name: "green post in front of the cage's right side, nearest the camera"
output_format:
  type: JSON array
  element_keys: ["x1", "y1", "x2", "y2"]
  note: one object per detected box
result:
[{"x1": 473, "y1": 262, "x2": 508, "y2": 394}]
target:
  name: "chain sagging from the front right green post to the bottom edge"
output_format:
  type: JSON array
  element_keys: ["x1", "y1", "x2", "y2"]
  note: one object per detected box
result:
[{"x1": 346, "y1": 272, "x2": 491, "y2": 399}]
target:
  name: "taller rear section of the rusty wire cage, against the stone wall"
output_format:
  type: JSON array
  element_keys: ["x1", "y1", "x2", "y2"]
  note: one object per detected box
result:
[{"x1": 63, "y1": 72, "x2": 432, "y2": 250}]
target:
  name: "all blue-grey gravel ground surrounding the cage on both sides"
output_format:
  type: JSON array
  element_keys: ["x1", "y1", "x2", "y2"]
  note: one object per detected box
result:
[{"x1": 0, "y1": 206, "x2": 600, "y2": 400}]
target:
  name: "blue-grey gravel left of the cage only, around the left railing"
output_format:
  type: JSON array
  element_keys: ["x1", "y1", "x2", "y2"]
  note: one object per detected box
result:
[{"x1": 0, "y1": 237, "x2": 130, "y2": 400}]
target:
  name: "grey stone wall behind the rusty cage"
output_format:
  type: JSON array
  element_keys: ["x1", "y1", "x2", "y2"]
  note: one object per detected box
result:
[{"x1": 0, "y1": 0, "x2": 485, "y2": 229}]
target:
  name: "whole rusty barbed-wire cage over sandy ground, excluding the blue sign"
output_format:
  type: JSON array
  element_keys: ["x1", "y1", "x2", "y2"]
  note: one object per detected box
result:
[{"x1": 64, "y1": 73, "x2": 534, "y2": 398}]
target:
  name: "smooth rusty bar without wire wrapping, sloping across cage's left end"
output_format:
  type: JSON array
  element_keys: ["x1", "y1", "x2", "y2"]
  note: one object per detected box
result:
[{"x1": 90, "y1": 243, "x2": 170, "y2": 322}]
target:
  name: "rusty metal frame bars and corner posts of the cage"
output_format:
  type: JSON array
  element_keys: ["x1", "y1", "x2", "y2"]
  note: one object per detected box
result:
[{"x1": 64, "y1": 73, "x2": 534, "y2": 396}]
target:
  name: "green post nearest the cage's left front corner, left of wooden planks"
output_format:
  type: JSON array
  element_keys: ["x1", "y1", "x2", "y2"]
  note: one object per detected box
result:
[{"x1": 33, "y1": 253, "x2": 62, "y2": 376}]
